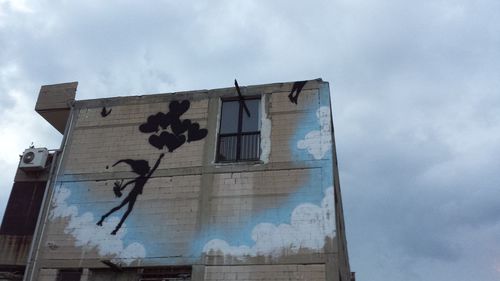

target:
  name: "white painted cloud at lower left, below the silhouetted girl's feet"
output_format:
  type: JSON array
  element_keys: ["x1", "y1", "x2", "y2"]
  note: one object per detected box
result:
[{"x1": 50, "y1": 187, "x2": 146, "y2": 264}]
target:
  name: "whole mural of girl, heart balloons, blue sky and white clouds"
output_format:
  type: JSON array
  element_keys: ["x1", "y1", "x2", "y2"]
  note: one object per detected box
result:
[{"x1": 51, "y1": 85, "x2": 335, "y2": 265}]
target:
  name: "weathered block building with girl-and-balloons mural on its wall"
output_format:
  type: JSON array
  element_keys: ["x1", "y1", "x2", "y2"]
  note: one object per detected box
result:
[{"x1": 0, "y1": 79, "x2": 353, "y2": 281}]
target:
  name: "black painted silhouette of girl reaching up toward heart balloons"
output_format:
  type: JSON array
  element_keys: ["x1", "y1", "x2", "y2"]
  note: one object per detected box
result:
[{"x1": 97, "y1": 153, "x2": 165, "y2": 235}]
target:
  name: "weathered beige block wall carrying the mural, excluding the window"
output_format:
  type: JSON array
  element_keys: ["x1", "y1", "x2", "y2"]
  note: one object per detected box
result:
[{"x1": 37, "y1": 81, "x2": 336, "y2": 280}]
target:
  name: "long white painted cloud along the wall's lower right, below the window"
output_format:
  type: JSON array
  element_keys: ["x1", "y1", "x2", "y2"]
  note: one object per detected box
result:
[{"x1": 203, "y1": 187, "x2": 335, "y2": 257}]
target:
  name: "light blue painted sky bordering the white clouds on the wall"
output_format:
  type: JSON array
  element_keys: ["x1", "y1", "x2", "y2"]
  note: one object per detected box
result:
[{"x1": 56, "y1": 105, "x2": 333, "y2": 258}]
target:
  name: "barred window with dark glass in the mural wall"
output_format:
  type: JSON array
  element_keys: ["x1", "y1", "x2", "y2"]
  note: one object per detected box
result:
[{"x1": 216, "y1": 97, "x2": 260, "y2": 162}]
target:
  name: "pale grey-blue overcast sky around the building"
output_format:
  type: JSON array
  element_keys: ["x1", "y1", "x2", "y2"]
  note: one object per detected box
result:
[{"x1": 0, "y1": 0, "x2": 500, "y2": 281}]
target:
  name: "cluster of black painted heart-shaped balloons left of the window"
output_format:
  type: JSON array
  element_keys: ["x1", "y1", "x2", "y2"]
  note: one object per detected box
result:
[{"x1": 139, "y1": 100, "x2": 208, "y2": 152}]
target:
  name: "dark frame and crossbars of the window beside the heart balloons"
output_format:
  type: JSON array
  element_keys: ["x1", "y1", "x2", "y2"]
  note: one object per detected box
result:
[{"x1": 215, "y1": 95, "x2": 263, "y2": 164}]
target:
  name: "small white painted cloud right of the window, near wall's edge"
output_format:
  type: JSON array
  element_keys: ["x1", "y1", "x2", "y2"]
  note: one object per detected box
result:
[{"x1": 297, "y1": 106, "x2": 332, "y2": 160}]
